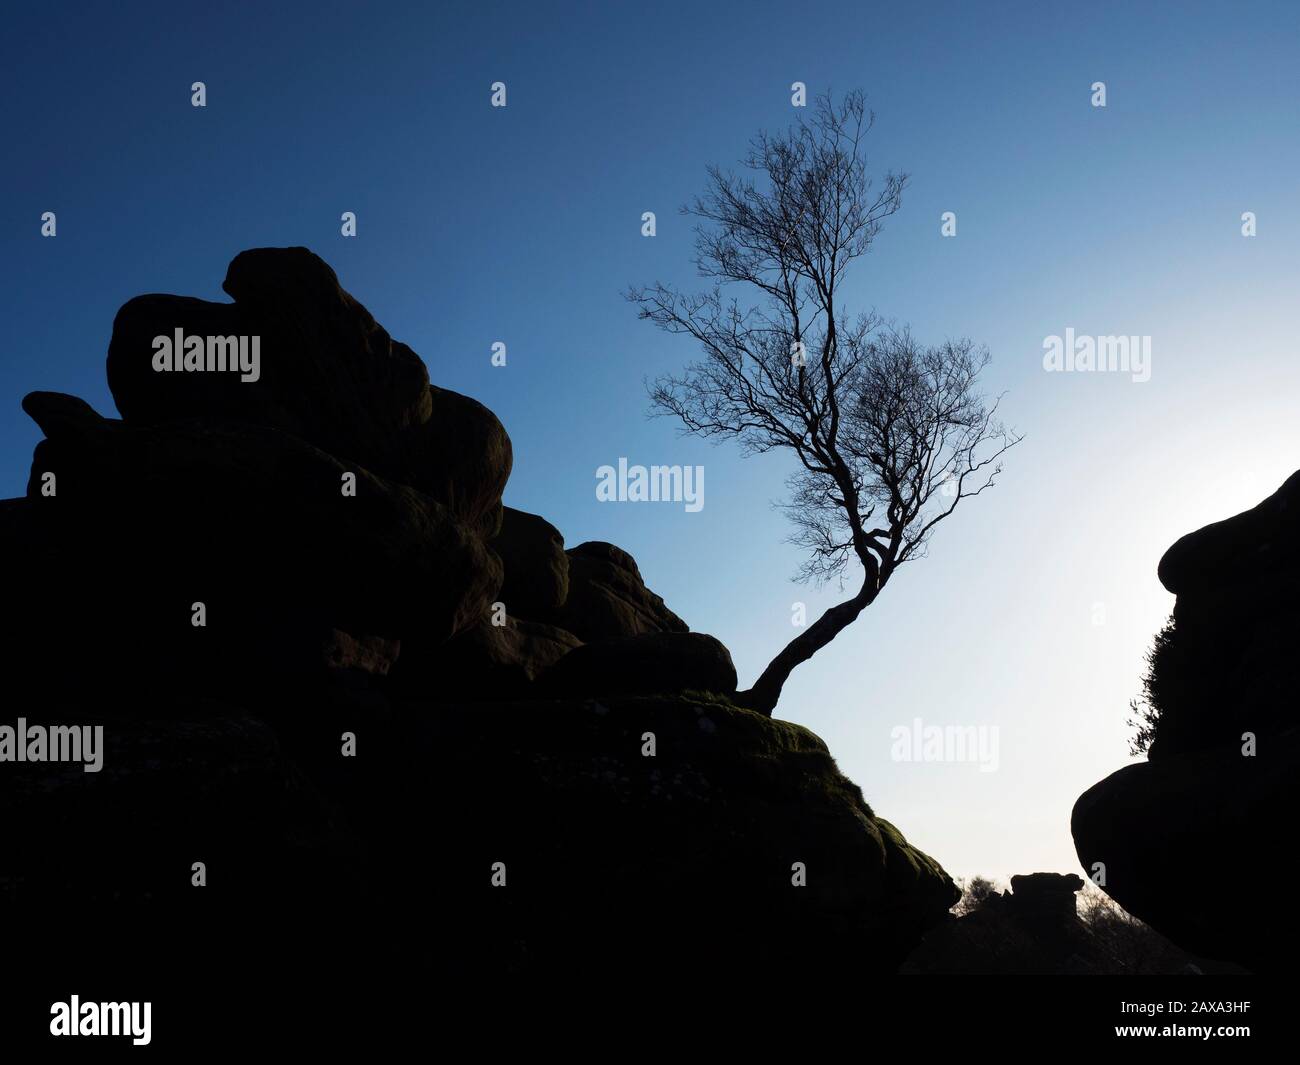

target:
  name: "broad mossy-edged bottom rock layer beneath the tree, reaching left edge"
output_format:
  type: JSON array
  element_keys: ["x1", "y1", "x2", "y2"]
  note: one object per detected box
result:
[{"x1": 0, "y1": 698, "x2": 958, "y2": 987}]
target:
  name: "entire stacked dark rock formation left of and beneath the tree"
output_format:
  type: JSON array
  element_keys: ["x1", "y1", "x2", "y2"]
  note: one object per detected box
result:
[{"x1": 0, "y1": 248, "x2": 957, "y2": 979}]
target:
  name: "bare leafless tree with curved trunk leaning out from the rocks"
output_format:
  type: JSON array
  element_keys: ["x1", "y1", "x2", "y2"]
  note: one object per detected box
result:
[{"x1": 628, "y1": 92, "x2": 1019, "y2": 714}]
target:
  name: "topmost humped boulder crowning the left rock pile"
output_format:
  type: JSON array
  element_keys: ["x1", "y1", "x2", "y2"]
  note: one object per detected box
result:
[{"x1": 108, "y1": 247, "x2": 512, "y2": 536}]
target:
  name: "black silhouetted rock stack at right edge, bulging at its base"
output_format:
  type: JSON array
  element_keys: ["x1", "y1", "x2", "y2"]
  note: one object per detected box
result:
[{"x1": 1071, "y1": 473, "x2": 1300, "y2": 970}]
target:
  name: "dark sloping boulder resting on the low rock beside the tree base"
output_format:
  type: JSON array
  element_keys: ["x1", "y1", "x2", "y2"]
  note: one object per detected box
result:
[{"x1": 540, "y1": 540, "x2": 686, "y2": 644}]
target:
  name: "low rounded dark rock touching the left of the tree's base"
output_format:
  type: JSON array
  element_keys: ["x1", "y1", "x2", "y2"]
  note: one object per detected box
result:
[{"x1": 542, "y1": 632, "x2": 736, "y2": 696}]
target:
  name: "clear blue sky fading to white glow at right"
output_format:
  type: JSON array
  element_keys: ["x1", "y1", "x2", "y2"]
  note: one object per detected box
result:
[{"x1": 0, "y1": 0, "x2": 1300, "y2": 876}]
